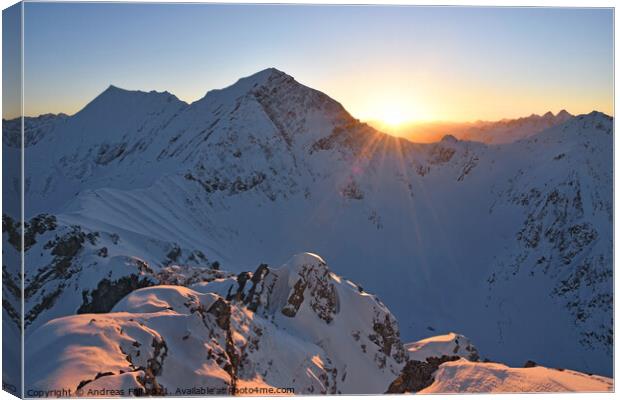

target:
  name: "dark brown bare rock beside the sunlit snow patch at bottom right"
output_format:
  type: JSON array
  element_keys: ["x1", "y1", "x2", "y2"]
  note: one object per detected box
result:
[{"x1": 386, "y1": 356, "x2": 460, "y2": 393}]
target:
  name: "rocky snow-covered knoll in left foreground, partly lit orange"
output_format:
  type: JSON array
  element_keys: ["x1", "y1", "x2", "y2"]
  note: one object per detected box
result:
[{"x1": 26, "y1": 254, "x2": 406, "y2": 395}]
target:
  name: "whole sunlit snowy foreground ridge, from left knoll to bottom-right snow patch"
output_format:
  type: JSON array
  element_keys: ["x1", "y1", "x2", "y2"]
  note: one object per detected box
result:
[{"x1": 26, "y1": 253, "x2": 612, "y2": 397}]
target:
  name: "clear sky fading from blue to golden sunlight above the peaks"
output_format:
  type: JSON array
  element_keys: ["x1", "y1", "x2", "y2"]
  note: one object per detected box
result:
[{"x1": 3, "y1": 3, "x2": 613, "y2": 124}]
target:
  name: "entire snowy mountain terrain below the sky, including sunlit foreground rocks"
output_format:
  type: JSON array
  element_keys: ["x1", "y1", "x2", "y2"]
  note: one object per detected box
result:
[{"x1": 3, "y1": 69, "x2": 613, "y2": 394}]
